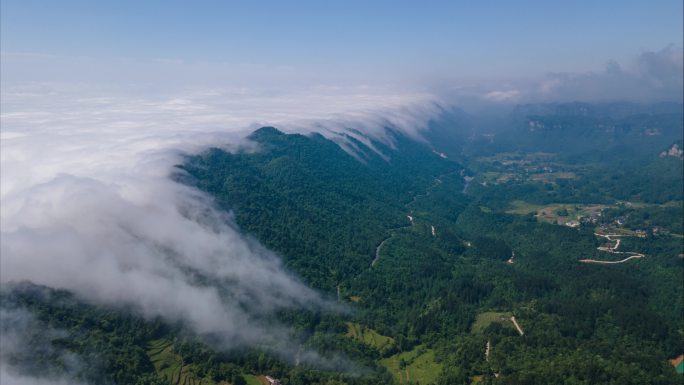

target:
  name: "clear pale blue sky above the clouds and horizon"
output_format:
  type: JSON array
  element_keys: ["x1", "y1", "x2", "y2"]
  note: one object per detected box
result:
[{"x1": 1, "y1": 0, "x2": 684, "y2": 101}]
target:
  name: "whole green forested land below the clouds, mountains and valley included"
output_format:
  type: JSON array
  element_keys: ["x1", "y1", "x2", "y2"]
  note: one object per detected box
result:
[{"x1": 1, "y1": 105, "x2": 684, "y2": 385}]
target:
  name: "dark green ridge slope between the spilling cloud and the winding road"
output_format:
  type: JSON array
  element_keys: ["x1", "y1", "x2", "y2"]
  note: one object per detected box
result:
[{"x1": 176, "y1": 128, "x2": 453, "y2": 290}]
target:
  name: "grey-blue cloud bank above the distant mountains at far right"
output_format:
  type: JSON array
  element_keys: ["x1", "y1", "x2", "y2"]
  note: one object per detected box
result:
[{"x1": 436, "y1": 45, "x2": 684, "y2": 108}]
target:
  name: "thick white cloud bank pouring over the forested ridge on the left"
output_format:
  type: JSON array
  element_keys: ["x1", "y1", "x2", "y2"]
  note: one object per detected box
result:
[{"x1": 0, "y1": 83, "x2": 435, "y2": 360}]
